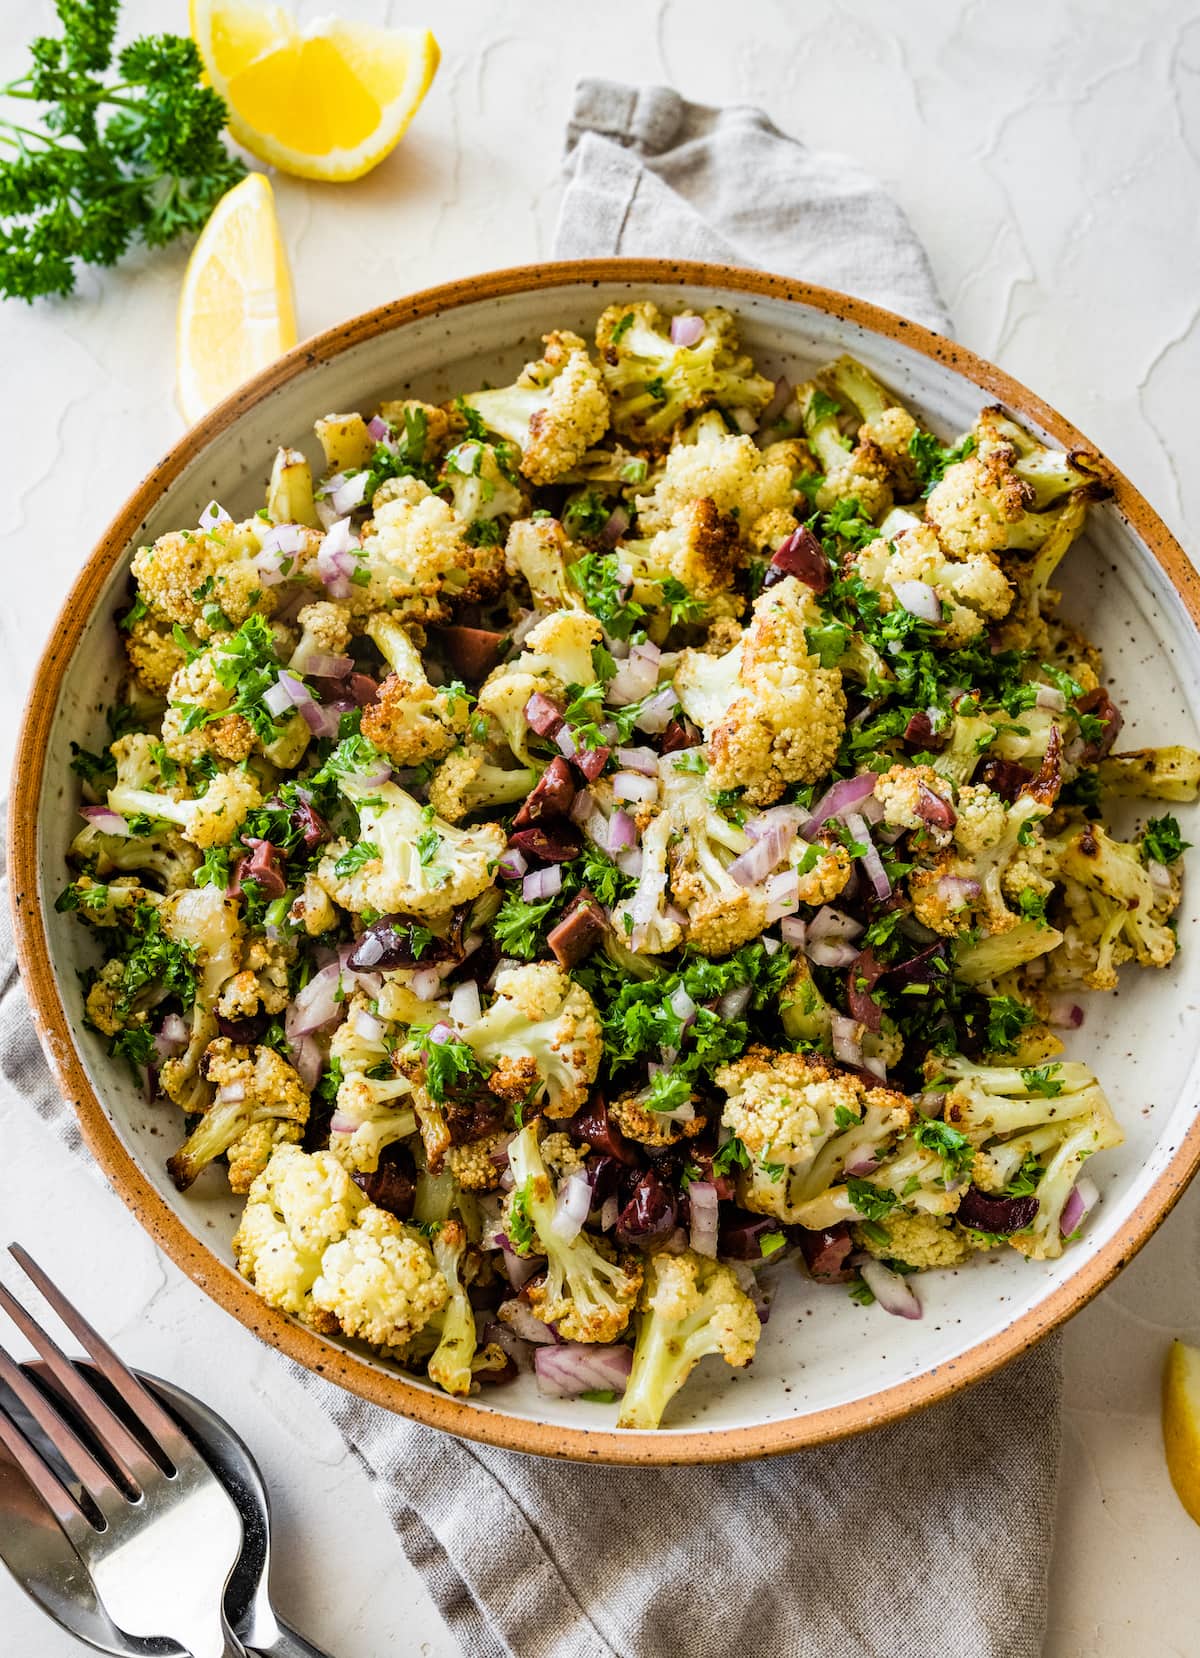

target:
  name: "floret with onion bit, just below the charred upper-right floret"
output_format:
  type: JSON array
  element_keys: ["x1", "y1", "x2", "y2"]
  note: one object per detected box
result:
[{"x1": 854, "y1": 524, "x2": 1013, "y2": 650}]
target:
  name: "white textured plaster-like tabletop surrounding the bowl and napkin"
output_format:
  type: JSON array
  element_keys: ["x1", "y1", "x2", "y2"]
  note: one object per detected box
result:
[{"x1": 0, "y1": 0, "x2": 1200, "y2": 1658}]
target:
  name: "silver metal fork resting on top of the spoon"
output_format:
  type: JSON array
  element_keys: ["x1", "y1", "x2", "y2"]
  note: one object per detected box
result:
[{"x1": 0, "y1": 1244, "x2": 247, "y2": 1658}]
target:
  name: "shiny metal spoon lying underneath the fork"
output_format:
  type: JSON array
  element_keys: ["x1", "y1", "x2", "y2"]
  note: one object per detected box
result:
[{"x1": 0, "y1": 1361, "x2": 328, "y2": 1658}]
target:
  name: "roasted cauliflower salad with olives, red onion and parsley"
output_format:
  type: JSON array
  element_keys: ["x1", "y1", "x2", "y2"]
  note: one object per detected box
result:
[{"x1": 58, "y1": 302, "x2": 1200, "y2": 1429}]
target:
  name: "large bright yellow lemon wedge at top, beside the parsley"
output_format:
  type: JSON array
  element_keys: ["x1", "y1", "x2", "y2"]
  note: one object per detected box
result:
[{"x1": 191, "y1": 0, "x2": 441, "y2": 182}]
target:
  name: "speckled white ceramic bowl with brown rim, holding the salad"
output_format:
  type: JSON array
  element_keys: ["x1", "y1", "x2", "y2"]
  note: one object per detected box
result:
[{"x1": 10, "y1": 260, "x2": 1200, "y2": 1462}]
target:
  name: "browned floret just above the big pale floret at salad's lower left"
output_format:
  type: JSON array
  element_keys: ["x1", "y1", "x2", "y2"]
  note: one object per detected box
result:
[{"x1": 167, "y1": 1036, "x2": 308, "y2": 1192}]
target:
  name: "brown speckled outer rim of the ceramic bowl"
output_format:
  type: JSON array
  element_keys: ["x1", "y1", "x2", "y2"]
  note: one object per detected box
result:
[{"x1": 8, "y1": 259, "x2": 1200, "y2": 1466}]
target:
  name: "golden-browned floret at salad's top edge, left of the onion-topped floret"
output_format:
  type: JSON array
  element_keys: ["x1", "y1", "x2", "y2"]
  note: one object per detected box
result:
[{"x1": 462, "y1": 332, "x2": 608, "y2": 484}]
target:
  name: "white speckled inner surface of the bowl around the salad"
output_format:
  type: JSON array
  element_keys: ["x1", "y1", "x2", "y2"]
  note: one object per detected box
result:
[{"x1": 38, "y1": 284, "x2": 1200, "y2": 1431}]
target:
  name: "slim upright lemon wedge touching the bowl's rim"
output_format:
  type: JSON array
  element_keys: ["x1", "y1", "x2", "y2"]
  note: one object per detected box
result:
[{"x1": 176, "y1": 172, "x2": 295, "y2": 424}]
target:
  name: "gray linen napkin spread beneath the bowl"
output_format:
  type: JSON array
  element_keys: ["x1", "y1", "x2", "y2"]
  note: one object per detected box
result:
[{"x1": 0, "y1": 81, "x2": 1061, "y2": 1658}]
